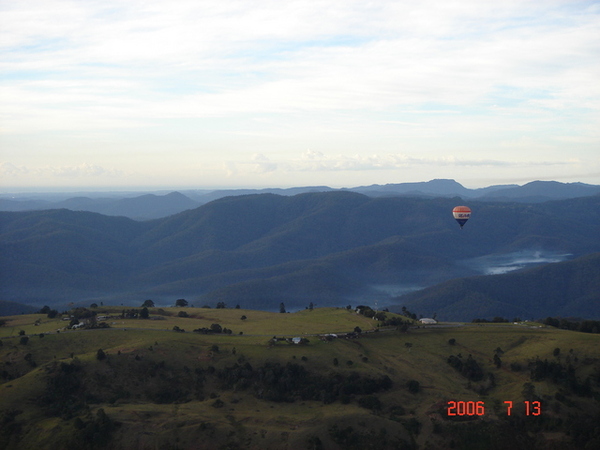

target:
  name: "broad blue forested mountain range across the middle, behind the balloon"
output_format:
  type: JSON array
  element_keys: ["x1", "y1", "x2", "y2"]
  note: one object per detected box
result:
[{"x1": 0, "y1": 187, "x2": 600, "y2": 320}]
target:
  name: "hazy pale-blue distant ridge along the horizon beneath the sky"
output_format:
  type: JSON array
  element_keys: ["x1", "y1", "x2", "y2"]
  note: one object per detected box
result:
[{"x1": 0, "y1": 179, "x2": 600, "y2": 220}]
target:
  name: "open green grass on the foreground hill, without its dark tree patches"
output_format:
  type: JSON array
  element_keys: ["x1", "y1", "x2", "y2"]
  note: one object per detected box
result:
[{"x1": 0, "y1": 308, "x2": 600, "y2": 448}]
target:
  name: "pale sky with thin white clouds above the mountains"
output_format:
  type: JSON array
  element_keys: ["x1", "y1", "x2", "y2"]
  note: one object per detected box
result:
[{"x1": 0, "y1": 0, "x2": 600, "y2": 190}]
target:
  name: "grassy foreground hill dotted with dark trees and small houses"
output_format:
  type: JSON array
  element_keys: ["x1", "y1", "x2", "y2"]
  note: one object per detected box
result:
[{"x1": 0, "y1": 307, "x2": 600, "y2": 450}]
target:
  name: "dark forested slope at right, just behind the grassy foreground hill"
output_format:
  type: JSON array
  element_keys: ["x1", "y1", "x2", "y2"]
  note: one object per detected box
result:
[{"x1": 390, "y1": 253, "x2": 600, "y2": 320}]
